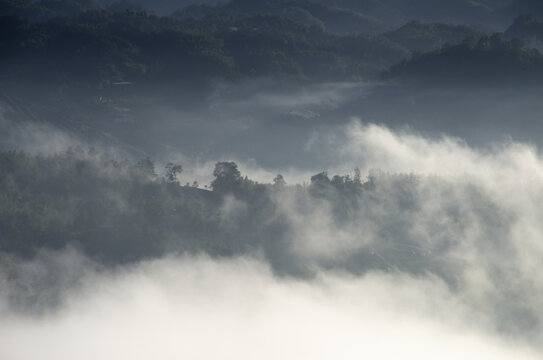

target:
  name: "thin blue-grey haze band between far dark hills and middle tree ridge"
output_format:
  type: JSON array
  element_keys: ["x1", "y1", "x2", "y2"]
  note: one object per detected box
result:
[{"x1": 6, "y1": 79, "x2": 543, "y2": 172}]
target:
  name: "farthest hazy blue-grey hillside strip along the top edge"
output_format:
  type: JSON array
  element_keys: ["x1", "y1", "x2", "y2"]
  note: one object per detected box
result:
[{"x1": 0, "y1": 0, "x2": 520, "y2": 27}]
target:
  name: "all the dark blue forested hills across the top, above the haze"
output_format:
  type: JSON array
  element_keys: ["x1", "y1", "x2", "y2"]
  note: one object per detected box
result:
[{"x1": 0, "y1": 0, "x2": 541, "y2": 89}]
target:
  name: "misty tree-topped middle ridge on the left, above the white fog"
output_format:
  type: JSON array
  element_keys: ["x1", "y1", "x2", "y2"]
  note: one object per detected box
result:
[{"x1": 0, "y1": 149, "x2": 372, "y2": 264}]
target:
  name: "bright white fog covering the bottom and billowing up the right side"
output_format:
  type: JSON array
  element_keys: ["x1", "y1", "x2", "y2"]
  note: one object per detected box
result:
[{"x1": 0, "y1": 116, "x2": 543, "y2": 359}]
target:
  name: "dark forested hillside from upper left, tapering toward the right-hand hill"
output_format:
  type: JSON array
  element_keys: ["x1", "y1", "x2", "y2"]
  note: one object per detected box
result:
[{"x1": 0, "y1": 5, "x2": 408, "y2": 86}]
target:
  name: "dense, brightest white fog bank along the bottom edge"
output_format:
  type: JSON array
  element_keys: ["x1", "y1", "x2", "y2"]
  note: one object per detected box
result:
[{"x1": 0, "y1": 258, "x2": 538, "y2": 360}]
